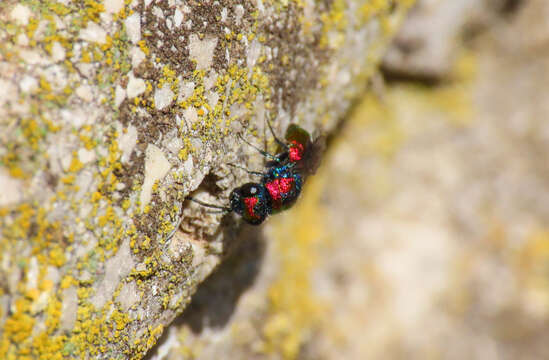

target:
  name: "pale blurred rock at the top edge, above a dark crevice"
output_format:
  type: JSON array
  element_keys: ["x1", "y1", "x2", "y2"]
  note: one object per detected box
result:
[{"x1": 382, "y1": 0, "x2": 522, "y2": 81}]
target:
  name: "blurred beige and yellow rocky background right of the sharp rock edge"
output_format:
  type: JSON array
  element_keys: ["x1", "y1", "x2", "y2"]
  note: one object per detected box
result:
[{"x1": 149, "y1": 0, "x2": 549, "y2": 360}]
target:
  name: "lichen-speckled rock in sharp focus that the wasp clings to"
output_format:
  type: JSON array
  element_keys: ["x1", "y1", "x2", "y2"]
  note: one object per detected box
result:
[{"x1": 0, "y1": 0, "x2": 413, "y2": 359}]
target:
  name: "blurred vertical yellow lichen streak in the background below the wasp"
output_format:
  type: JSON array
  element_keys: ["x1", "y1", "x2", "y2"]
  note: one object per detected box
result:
[{"x1": 262, "y1": 176, "x2": 327, "y2": 359}]
